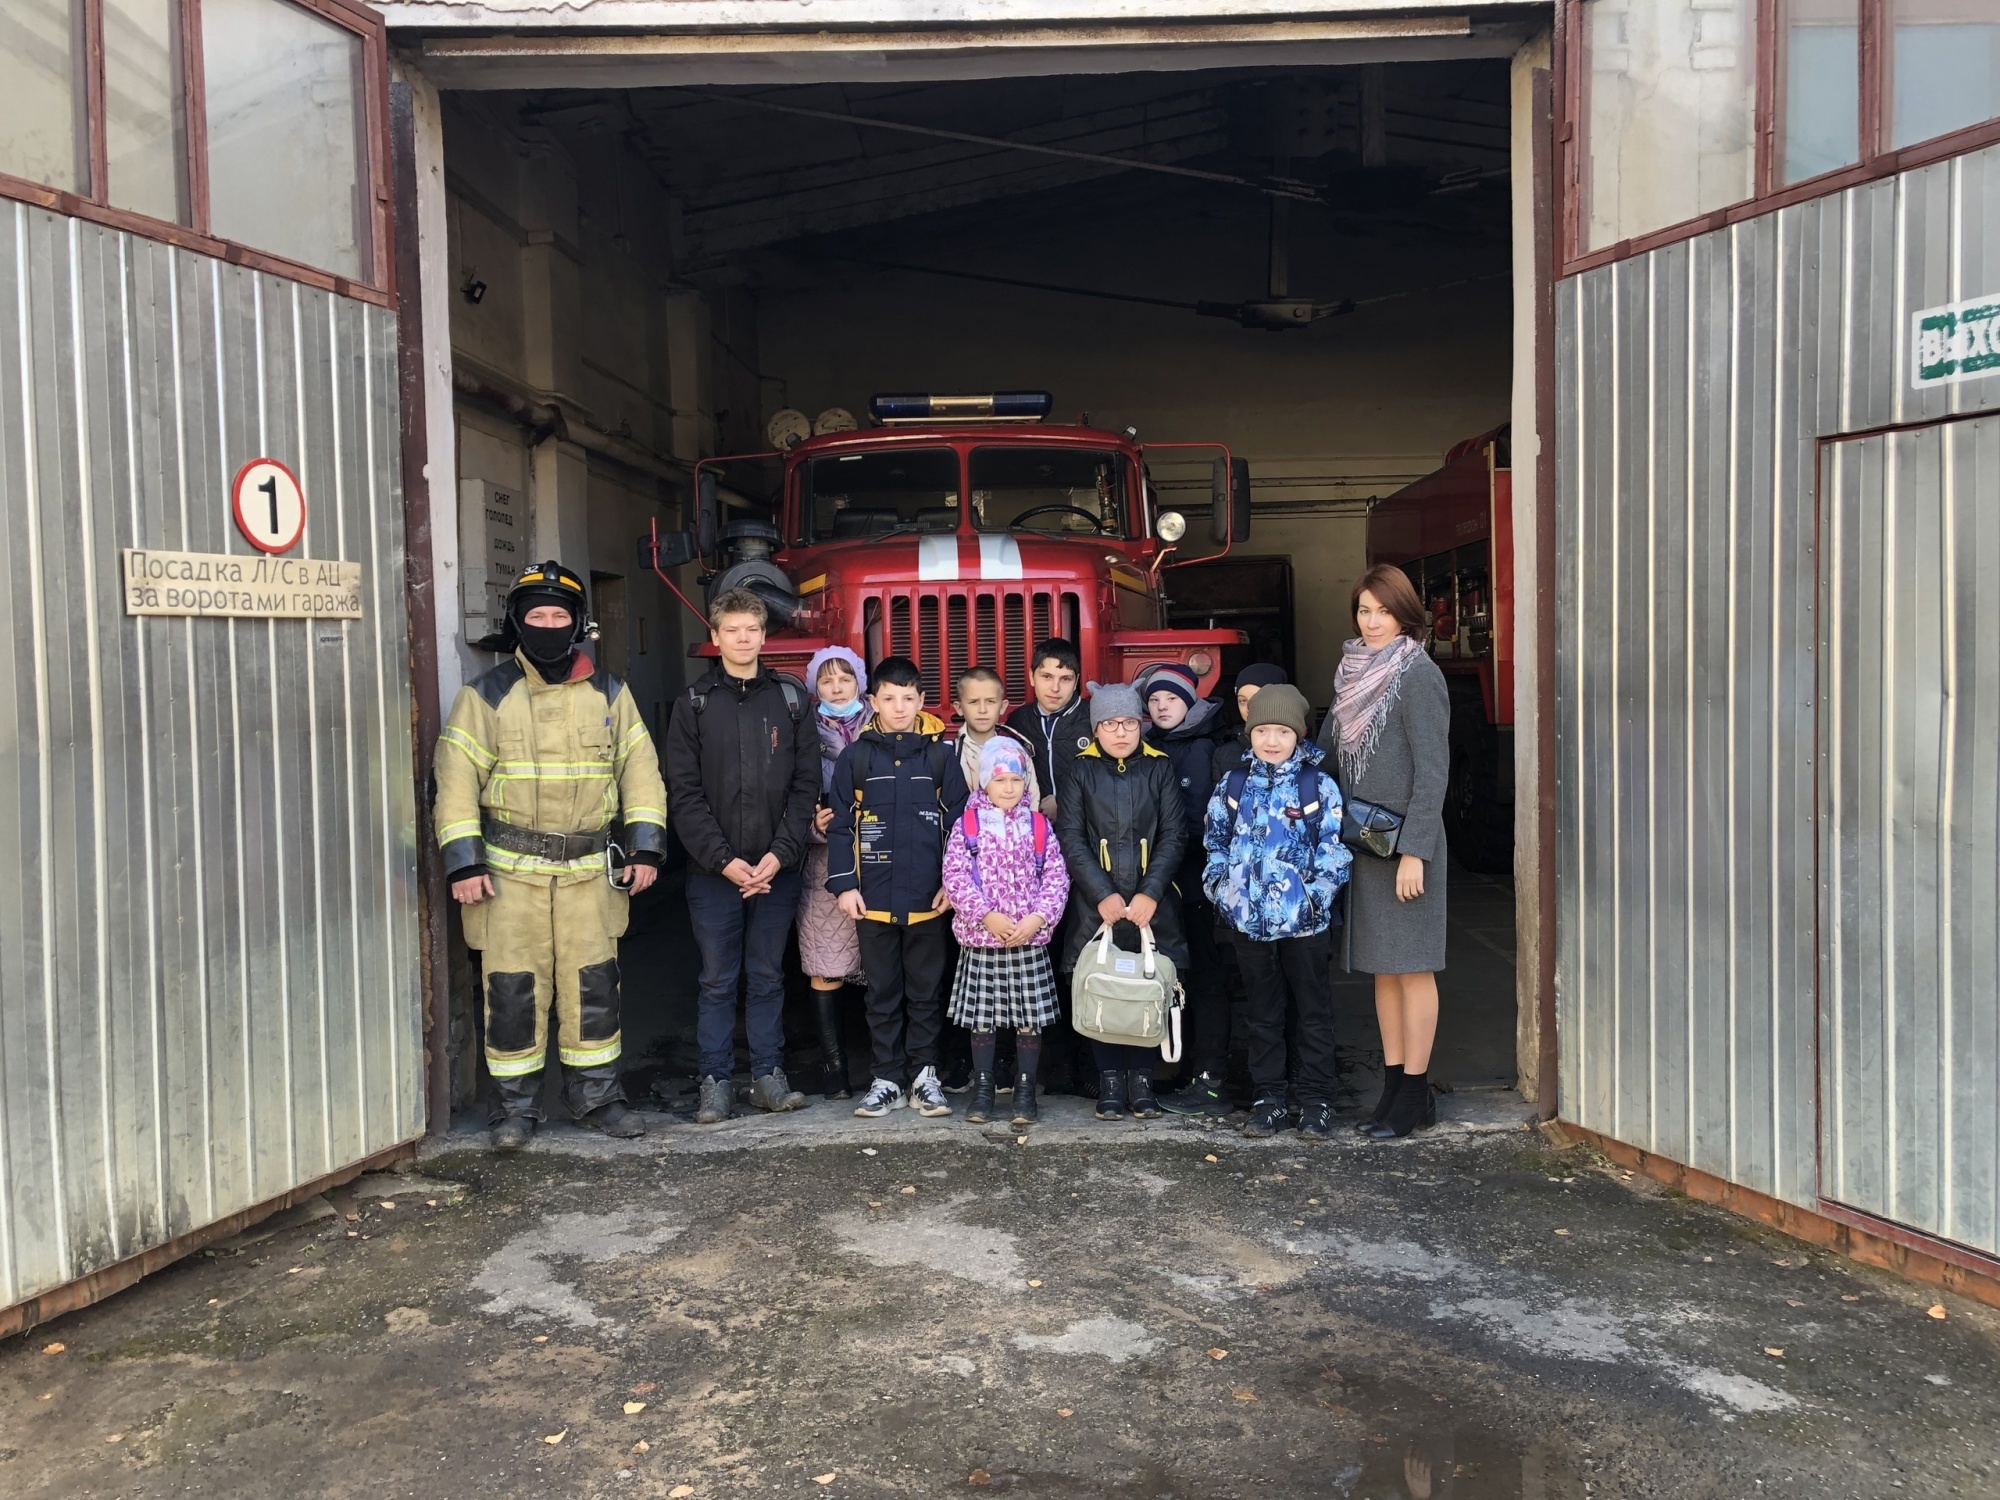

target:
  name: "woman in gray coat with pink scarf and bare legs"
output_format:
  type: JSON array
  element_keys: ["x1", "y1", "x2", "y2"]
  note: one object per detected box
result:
[{"x1": 1320, "y1": 564, "x2": 1452, "y2": 1140}]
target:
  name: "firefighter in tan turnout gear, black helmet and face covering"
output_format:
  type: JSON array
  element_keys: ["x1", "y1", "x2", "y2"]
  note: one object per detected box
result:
[{"x1": 436, "y1": 562, "x2": 666, "y2": 1150}]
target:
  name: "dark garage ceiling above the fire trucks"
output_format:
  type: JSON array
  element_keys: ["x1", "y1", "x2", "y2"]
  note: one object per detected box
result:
[{"x1": 508, "y1": 60, "x2": 1508, "y2": 272}]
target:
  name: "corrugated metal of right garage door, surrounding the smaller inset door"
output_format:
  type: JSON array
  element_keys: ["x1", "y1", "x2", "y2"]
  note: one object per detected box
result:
[{"x1": 1554, "y1": 148, "x2": 2000, "y2": 1208}]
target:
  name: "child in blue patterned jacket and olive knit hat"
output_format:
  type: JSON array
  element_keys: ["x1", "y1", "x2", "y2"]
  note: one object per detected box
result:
[{"x1": 1202, "y1": 682, "x2": 1354, "y2": 1140}]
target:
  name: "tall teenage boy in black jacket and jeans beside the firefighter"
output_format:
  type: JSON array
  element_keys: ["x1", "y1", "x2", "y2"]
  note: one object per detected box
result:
[{"x1": 666, "y1": 588, "x2": 820, "y2": 1124}]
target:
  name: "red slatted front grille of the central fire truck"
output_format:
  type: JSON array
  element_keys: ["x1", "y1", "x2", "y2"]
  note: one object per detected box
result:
[{"x1": 862, "y1": 588, "x2": 1080, "y2": 704}]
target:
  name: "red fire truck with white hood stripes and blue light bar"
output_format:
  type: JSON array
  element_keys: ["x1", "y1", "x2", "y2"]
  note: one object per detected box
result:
[{"x1": 640, "y1": 392, "x2": 1250, "y2": 716}]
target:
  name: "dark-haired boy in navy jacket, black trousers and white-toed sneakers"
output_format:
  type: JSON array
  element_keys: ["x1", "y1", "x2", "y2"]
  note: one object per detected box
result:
[{"x1": 826, "y1": 656, "x2": 966, "y2": 1120}]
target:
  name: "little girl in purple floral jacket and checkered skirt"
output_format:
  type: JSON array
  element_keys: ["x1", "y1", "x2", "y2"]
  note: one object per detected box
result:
[{"x1": 944, "y1": 736, "x2": 1070, "y2": 1126}]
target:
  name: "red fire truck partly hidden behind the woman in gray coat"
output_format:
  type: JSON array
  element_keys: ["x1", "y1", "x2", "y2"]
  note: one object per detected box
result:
[{"x1": 1368, "y1": 428, "x2": 1514, "y2": 874}]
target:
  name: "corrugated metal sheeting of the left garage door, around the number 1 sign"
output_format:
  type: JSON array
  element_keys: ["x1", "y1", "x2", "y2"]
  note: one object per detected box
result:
[{"x1": 0, "y1": 202, "x2": 422, "y2": 1308}]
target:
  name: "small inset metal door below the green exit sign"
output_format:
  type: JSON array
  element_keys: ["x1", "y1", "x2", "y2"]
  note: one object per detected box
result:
[{"x1": 1820, "y1": 416, "x2": 2000, "y2": 1252}]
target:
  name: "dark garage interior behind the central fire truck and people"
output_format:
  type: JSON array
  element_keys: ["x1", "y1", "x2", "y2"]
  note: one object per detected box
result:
[{"x1": 430, "y1": 56, "x2": 1516, "y2": 1102}]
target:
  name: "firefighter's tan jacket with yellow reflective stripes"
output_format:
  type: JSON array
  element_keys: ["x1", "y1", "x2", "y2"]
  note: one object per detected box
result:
[{"x1": 436, "y1": 652, "x2": 666, "y2": 884}]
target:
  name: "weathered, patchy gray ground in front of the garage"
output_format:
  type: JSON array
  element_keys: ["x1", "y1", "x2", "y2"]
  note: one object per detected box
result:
[{"x1": 0, "y1": 1094, "x2": 2000, "y2": 1500}]
